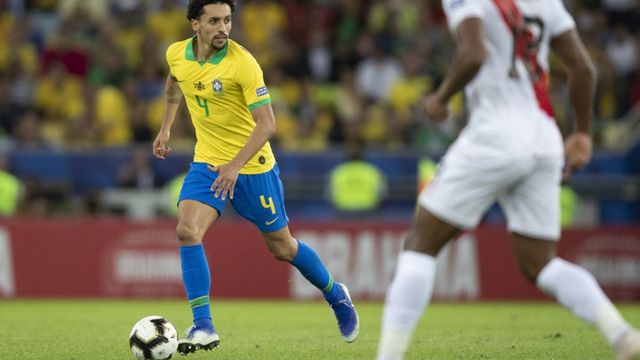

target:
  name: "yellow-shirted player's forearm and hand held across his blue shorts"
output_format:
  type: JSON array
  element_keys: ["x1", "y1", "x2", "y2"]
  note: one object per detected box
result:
[{"x1": 209, "y1": 104, "x2": 276, "y2": 200}]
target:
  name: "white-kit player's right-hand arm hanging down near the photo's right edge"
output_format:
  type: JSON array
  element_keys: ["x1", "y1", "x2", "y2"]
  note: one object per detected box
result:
[{"x1": 551, "y1": 29, "x2": 596, "y2": 178}]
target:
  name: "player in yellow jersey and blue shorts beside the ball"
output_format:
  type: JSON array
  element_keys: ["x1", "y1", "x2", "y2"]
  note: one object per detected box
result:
[{"x1": 153, "y1": 0, "x2": 359, "y2": 354}]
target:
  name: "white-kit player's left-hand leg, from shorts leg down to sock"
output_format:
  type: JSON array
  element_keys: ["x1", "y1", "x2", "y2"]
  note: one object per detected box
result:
[{"x1": 378, "y1": 147, "x2": 502, "y2": 360}]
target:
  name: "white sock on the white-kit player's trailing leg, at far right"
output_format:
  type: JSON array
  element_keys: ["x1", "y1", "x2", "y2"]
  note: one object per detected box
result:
[{"x1": 537, "y1": 258, "x2": 631, "y2": 345}]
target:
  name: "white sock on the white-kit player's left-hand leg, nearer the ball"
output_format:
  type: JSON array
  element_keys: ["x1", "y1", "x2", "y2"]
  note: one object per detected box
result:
[{"x1": 377, "y1": 251, "x2": 436, "y2": 360}]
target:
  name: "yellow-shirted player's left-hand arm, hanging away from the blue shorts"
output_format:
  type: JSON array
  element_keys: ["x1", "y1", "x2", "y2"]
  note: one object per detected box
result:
[{"x1": 153, "y1": 74, "x2": 183, "y2": 159}]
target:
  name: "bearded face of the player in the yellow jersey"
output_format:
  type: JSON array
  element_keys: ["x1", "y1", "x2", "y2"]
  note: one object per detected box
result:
[{"x1": 191, "y1": 3, "x2": 231, "y2": 50}]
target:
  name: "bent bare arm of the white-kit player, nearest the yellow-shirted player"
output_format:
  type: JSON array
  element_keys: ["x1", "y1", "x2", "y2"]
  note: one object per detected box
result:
[{"x1": 425, "y1": 17, "x2": 486, "y2": 121}]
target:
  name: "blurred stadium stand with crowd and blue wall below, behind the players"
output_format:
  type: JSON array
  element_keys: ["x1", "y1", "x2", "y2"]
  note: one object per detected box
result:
[{"x1": 0, "y1": 0, "x2": 640, "y2": 224}]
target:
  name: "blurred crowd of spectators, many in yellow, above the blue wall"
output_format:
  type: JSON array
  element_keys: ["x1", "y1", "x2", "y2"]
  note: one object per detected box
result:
[{"x1": 0, "y1": 0, "x2": 640, "y2": 217}]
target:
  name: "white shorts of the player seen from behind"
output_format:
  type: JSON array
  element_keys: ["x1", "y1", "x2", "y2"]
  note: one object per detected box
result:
[{"x1": 418, "y1": 136, "x2": 563, "y2": 240}]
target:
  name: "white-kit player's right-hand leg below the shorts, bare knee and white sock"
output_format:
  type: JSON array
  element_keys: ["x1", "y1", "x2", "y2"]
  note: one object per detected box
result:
[{"x1": 512, "y1": 233, "x2": 640, "y2": 359}]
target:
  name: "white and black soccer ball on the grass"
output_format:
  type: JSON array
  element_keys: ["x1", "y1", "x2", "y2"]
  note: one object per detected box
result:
[{"x1": 129, "y1": 315, "x2": 178, "y2": 360}]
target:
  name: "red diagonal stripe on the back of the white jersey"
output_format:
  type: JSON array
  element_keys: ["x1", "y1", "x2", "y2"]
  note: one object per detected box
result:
[{"x1": 493, "y1": 0, "x2": 553, "y2": 117}]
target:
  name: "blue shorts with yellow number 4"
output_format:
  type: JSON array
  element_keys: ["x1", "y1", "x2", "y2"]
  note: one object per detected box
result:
[{"x1": 178, "y1": 162, "x2": 289, "y2": 232}]
